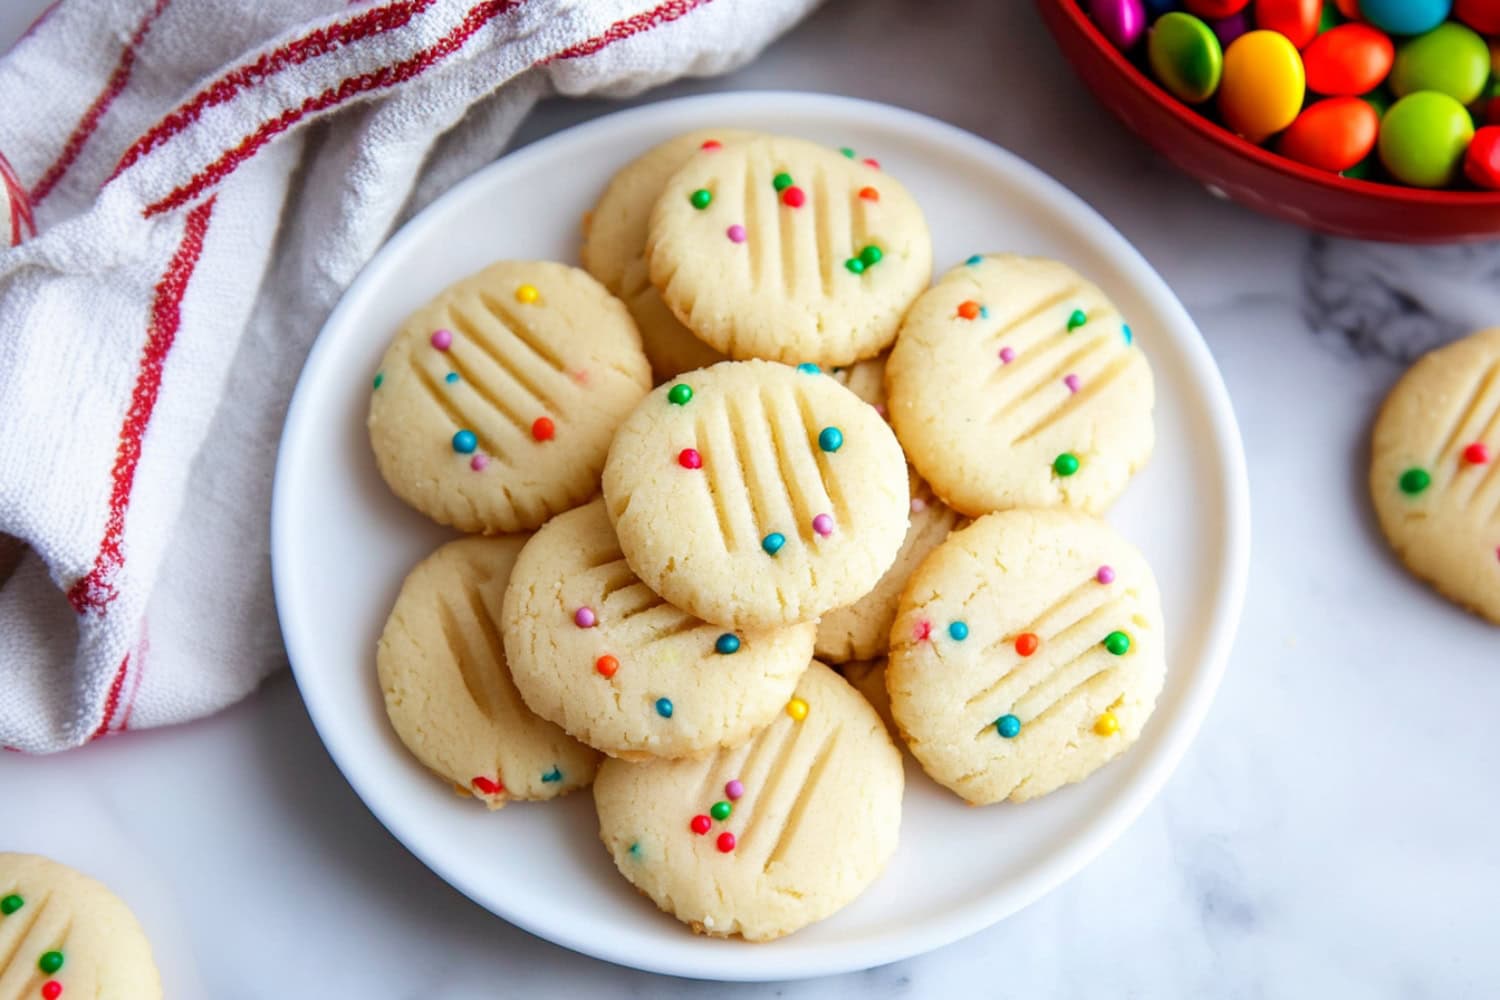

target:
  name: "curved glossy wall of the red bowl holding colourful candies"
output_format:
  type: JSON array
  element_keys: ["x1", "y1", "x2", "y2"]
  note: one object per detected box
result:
[{"x1": 1037, "y1": 0, "x2": 1500, "y2": 243}]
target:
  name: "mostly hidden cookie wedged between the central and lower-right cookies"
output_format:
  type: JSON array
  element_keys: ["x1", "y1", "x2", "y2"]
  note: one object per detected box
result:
[{"x1": 818, "y1": 475, "x2": 963, "y2": 663}]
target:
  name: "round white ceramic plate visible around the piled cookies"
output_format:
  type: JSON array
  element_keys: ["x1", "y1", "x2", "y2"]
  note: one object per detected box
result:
[{"x1": 272, "y1": 93, "x2": 1250, "y2": 979}]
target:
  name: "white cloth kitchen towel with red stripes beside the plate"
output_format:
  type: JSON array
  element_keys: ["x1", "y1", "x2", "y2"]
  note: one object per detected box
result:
[{"x1": 0, "y1": 0, "x2": 816, "y2": 753}]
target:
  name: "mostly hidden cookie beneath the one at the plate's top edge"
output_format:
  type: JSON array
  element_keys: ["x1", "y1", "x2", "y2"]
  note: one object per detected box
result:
[{"x1": 581, "y1": 129, "x2": 758, "y2": 382}]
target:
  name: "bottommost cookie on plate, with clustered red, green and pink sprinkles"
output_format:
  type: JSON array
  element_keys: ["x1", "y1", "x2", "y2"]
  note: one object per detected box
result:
[{"x1": 594, "y1": 663, "x2": 905, "y2": 942}]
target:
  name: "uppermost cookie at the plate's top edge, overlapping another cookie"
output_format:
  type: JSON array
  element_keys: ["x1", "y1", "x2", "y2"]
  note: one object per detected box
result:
[{"x1": 647, "y1": 136, "x2": 932, "y2": 364}]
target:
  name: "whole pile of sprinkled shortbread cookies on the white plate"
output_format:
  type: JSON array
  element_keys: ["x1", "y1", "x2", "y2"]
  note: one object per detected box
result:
[{"x1": 369, "y1": 130, "x2": 1166, "y2": 940}]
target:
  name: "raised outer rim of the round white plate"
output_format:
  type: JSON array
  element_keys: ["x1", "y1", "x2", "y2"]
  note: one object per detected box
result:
[{"x1": 270, "y1": 90, "x2": 1251, "y2": 982}]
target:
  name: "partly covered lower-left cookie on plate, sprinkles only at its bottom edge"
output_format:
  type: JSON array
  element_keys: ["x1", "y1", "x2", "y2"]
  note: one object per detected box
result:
[{"x1": 375, "y1": 535, "x2": 599, "y2": 810}]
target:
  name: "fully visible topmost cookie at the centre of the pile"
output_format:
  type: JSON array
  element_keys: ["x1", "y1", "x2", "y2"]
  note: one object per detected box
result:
[{"x1": 605, "y1": 361, "x2": 911, "y2": 628}]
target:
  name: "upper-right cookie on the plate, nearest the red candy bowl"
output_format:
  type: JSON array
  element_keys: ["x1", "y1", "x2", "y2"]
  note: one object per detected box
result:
[{"x1": 885, "y1": 253, "x2": 1155, "y2": 517}]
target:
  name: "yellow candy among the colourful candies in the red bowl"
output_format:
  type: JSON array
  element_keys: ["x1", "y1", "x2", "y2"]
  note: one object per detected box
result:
[{"x1": 1218, "y1": 31, "x2": 1307, "y2": 142}]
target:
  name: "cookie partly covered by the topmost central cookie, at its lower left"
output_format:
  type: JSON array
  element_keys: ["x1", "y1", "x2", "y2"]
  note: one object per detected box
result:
[{"x1": 504, "y1": 501, "x2": 816, "y2": 760}]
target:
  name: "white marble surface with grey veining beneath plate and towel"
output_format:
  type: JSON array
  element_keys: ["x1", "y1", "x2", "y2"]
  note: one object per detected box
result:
[{"x1": 0, "y1": 0, "x2": 1500, "y2": 1000}]
